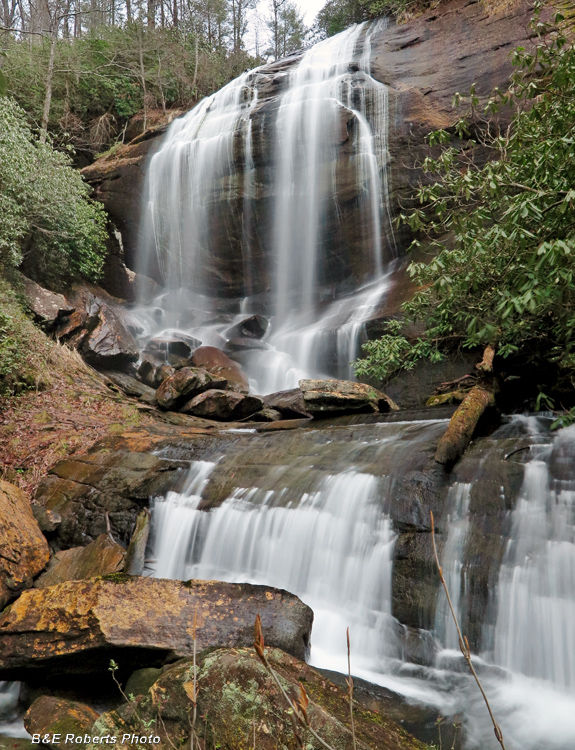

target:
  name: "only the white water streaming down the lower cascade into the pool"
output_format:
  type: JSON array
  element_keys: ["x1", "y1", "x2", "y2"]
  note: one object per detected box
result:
[{"x1": 148, "y1": 418, "x2": 575, "y2": 750}]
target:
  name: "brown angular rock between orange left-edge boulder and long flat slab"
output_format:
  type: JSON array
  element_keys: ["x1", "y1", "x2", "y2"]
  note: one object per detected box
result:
[{"x1": 34, "y1": 534, "x2": 126, "y2": 589}]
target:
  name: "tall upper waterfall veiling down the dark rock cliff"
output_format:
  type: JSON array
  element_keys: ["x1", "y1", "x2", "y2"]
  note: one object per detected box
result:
[{"x1": 132, "y1": 19, "x2": 395, "y2": 393}]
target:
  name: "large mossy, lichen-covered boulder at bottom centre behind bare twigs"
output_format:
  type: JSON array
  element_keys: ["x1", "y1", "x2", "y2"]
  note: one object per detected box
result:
[{"x1": 89, "y1": 648, "x2": 427, "y2": 750}]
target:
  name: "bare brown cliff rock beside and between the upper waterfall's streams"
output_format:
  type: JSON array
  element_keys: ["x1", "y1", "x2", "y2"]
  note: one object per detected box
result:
[{"x1": 83, "y1": 0, "x2": 531, "y2": 290}]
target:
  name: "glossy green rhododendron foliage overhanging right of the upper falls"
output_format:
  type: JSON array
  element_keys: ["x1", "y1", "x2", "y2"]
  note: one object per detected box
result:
[{"x1": 356, "y1": 15, "x2": 575, "y2": 384}]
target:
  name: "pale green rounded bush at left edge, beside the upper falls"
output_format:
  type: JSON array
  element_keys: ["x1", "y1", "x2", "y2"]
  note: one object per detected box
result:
[{"x1": 0, "y1": 97, "x2": 106, "y2": 282}]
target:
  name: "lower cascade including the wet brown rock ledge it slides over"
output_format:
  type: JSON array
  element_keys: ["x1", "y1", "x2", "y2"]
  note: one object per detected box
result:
[{"x1": 152, "y1": 417, "x2": 575, "y2": 750}]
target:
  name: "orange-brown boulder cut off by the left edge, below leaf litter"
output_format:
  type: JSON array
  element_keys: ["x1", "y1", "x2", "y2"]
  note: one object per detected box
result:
[{"x1": 0, "y1": 480, "x2": 50, "y2": 610}]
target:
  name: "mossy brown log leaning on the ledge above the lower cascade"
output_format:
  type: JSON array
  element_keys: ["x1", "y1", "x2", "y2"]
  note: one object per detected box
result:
[{"x1": 435, "y1": 385, "x2": 495, "y2": 466}]
